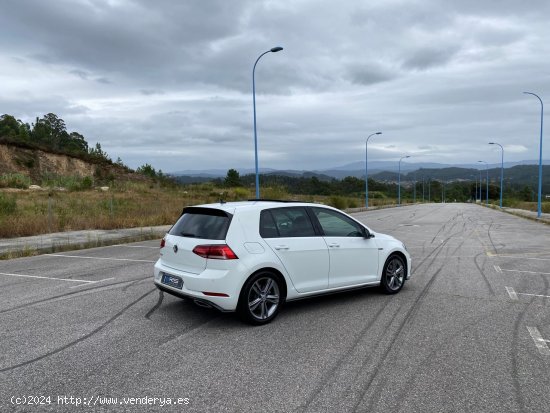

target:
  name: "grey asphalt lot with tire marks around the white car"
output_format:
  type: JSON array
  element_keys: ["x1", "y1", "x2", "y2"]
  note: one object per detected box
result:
[{"x1": 0, "y1": 204, "x2": 550, "y2": 413}]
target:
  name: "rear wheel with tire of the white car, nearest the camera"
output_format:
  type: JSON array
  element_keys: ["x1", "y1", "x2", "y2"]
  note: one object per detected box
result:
[{"x1": 237, "y1": 271, "x2": 284, "y2": 325}]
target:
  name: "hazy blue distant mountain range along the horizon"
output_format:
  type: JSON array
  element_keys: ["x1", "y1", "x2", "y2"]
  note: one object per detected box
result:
[{"x1": 170, "y1": 160, "x2": 550, "y2": 182}]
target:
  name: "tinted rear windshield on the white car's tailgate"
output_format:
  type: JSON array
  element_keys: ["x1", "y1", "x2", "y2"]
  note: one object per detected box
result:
[{"x1": 168, "y1": 208, "x2": 232, "y2": 240}]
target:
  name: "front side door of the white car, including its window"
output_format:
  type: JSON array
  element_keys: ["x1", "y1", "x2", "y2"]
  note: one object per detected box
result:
[{"x1": 312, "y1": 207, "x2": 378, "y2": 288}]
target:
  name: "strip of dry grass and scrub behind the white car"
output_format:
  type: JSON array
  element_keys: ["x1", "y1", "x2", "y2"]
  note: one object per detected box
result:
[{"x1": 0, "y1": 182, "x2": 402, "y2": 238}]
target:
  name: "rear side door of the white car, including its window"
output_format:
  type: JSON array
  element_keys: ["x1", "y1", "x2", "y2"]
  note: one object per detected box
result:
[{"x1": 260, "y1": 207, "x2": 329, "y2": 293}]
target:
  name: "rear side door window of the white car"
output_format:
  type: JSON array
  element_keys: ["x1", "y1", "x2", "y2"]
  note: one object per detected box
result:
[{"x1": 260, "y1": 207, "x2": 316, "y2": 238}]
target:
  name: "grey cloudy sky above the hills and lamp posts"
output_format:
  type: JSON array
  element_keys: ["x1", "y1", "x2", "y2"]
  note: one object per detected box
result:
[{"x1": 0, "y1": 0, "x2": 550, "y2": 172}]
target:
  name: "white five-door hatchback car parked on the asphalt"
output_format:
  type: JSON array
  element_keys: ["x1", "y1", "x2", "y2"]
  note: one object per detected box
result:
[{"x1": 154, "y1": 200, "x2": 411, "y2": 325}]
